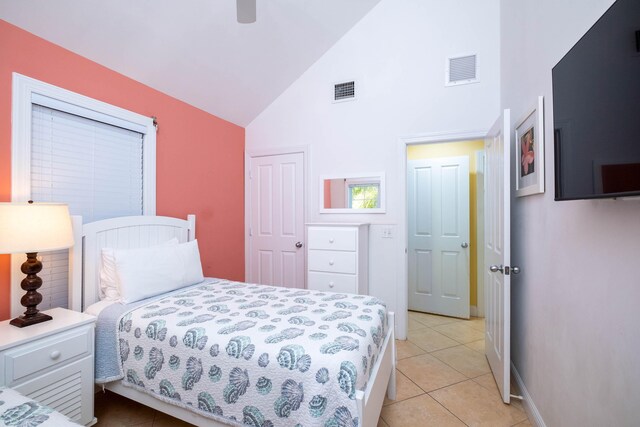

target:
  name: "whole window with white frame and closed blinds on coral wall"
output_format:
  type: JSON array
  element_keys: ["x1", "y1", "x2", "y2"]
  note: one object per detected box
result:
[{"x1": 11, "y1": 74, "x2": 155, "y2": 315}]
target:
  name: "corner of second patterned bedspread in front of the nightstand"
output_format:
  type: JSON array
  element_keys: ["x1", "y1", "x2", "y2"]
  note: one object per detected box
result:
[{"x1": 0, "y1": 387, "x2": 78, "y2": 427}]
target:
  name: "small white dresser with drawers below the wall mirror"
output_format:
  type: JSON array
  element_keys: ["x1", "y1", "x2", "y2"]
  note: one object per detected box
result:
[{"x1": 307, "y1": 223, "x2": 369, "y2": 295}]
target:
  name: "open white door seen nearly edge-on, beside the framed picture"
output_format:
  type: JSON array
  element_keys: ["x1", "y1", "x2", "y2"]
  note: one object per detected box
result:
[{"x1": 484, "y1": 110, "x2": 517, "y2": 403}]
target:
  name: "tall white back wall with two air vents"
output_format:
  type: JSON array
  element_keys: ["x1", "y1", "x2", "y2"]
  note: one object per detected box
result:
[{"x1": 246, "y1": 0, "x2": 500, "y2": 336}]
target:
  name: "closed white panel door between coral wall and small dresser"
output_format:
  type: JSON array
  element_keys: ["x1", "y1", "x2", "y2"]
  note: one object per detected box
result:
[{"x1": 247, "y1": 153, "x2": 305, "y2": 288}]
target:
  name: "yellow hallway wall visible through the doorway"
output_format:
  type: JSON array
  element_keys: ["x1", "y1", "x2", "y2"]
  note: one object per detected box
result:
[{"x1": 407, "y1": 140, "x2": 484, "y2": 306}]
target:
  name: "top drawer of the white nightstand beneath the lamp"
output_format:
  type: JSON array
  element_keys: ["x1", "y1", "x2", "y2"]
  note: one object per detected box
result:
[{"x1": 2, "y1": 325, "x2": 93, "y2": 386}]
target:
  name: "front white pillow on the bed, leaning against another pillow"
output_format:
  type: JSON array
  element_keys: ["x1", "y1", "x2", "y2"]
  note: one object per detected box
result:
[{"x1": 114, "y1": 240, "x2": 204, "y2": 304}]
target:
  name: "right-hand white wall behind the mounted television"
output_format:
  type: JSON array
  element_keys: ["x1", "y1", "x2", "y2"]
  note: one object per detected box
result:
[{"x1": 501, "y1": 0, "x2": 640, "y2": 426}]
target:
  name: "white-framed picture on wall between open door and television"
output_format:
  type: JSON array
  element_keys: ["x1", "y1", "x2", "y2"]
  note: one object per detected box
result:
[{"x1": 515, "y1": 96, "x2": 544, "y2": 197}]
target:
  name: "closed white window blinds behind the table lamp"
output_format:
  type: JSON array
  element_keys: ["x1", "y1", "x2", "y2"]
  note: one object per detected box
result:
[{"x1": 31, "y1": 104, "x2": 143, "y2": 310}]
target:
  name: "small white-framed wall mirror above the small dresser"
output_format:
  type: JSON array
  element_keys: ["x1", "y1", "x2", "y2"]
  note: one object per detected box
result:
[{"x1": 320, "y1": 173, "x2": 385, "y2": 214}]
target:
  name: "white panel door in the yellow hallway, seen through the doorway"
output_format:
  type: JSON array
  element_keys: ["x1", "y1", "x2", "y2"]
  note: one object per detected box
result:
[{"x1": 407, "y1": 156, "x2": 469, "y2": 319}]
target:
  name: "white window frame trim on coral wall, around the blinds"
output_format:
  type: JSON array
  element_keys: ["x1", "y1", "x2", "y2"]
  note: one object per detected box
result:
[{"x1": 10, "y1": 73, "x2": 156, "y2": 317}]
